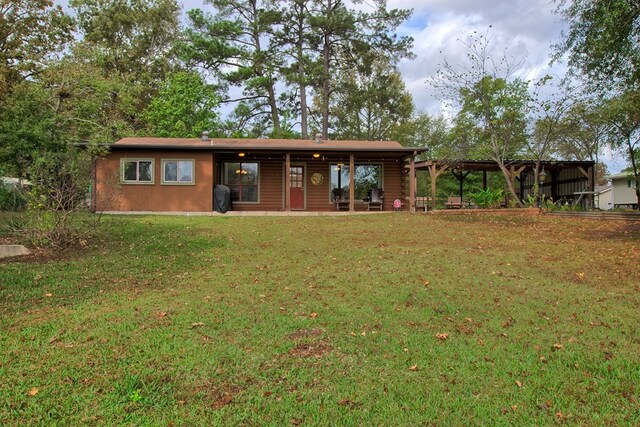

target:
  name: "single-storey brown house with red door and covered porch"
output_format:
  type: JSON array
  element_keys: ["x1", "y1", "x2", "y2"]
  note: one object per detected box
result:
[{"x1": 92, "y1": 133, "x2": 422, "y2": 212}]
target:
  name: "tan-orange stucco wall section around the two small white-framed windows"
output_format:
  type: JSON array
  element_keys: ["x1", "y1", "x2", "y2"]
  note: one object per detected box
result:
[{"x1": 95, "y1": 150, "x2": 215, "y2": 212}]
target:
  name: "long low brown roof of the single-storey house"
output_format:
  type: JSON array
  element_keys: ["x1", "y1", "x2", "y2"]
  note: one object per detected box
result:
[{"x1": 111, "y1": 137, "x2": 424, "y2": 152}]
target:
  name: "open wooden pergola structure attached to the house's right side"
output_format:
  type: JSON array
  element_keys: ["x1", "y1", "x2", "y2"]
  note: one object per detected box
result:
[{"x1": 410, "y1": 160, "x2": 595, "y2": 210}]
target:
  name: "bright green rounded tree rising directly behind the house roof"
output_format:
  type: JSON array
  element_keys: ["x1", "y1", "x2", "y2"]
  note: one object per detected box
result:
[{"x1": 144, "y1": 71, "x2": 220, "y2": 138}]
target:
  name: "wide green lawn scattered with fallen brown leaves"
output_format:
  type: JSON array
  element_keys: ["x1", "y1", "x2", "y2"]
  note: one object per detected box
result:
[{"x1": 0, "y1": 214, "x2": 640, "y2": 426}]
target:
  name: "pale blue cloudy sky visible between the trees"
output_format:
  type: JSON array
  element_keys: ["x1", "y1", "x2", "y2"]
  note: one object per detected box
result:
[{"x1": 56, "y1": 0, "x2": 625, "y2": 172}]
